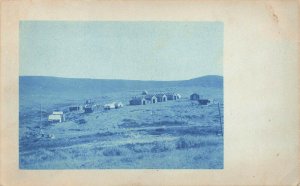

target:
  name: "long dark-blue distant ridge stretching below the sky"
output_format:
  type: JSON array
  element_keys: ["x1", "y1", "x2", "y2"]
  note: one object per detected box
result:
[{"x1": 19, "y1": 75, "x2": 223, "y2": 94}]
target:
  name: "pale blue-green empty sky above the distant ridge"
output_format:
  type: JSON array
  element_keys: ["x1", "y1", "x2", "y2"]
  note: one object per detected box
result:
[{"x1": 20, "y1": 21, "x2": 223, "y2": 81}]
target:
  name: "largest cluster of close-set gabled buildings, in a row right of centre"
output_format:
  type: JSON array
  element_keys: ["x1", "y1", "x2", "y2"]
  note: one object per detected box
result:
[{"x1": 129, "y1": 91, "x2": 181, "y2": 105}]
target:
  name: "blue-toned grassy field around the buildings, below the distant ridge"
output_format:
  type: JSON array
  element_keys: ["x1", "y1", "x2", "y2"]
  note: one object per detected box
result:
[{"x1": 19, "y1": 87, "x2": 223, "y2": 169}]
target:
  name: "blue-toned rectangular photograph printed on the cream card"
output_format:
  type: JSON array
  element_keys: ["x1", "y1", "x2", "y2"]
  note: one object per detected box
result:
[{"x1": 19, "y1": 21, "x2": 224, "y2": 170}]
